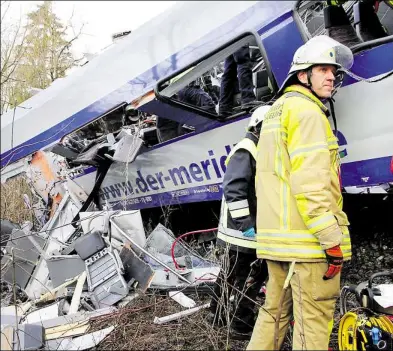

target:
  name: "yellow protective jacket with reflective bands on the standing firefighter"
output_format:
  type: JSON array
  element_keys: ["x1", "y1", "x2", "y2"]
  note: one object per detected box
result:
[{"x1": 256, "y1": 85, "x2": 351, "y2": 262}]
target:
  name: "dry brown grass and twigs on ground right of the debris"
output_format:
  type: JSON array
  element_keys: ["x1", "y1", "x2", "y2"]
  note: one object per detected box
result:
[{"x1": 92, "y1": 296, "x2": 247, "y2": 350}]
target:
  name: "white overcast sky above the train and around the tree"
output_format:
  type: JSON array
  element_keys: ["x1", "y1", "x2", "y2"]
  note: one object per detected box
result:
[{"x1": 2, "y1": 1, "x2": 176, "y2": 55}]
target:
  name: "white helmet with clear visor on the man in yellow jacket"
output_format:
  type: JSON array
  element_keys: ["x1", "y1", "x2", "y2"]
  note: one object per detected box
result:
[{"x1": 279, "y1": 35, "x2": 353, "y2": 93}]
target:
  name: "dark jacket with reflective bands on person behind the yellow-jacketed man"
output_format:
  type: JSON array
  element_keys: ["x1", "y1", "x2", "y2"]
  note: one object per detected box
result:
[{"x1": 217, "y1": 133, "x2": 257, "y2": 253}]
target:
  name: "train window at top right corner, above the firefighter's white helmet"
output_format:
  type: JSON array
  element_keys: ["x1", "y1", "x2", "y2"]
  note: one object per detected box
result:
[{"x1": 296, "y1": 0, "x2": 393, "y2": 48}]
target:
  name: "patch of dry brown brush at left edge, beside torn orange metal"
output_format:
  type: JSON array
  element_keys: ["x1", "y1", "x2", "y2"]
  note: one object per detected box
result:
[{"x1": 0, "y1": 176, "x2": 34, "y2": 223}]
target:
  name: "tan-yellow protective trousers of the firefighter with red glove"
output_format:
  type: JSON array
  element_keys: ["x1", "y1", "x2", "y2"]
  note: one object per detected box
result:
[{"x1": 247, "y1": 260, "x2": 340, "y2": 350}]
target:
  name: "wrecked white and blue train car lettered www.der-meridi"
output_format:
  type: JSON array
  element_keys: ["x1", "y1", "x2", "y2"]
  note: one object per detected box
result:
[{"x1": 1, "y1": 1, "x2": 393, "y2": 228}]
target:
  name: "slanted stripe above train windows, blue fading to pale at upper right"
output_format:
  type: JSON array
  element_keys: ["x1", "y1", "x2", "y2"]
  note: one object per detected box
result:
[{"x1": 0, "y1": 2, "x2": 288, "y2": 167}]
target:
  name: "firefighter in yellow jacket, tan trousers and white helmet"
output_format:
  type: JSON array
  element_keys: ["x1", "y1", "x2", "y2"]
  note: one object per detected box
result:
[{"x1": 247, "y1": 36, "x2": 353, "y2": 350}]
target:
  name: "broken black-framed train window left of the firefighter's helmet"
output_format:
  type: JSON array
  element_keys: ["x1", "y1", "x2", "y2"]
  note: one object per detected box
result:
[{"x1": 155, "y1": 32, "x2": 276, "y2": 120}]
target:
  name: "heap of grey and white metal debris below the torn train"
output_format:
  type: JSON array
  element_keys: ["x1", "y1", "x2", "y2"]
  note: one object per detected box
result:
[{"x1": 1, "y1": 188, "x2": 220, "y2": 350}]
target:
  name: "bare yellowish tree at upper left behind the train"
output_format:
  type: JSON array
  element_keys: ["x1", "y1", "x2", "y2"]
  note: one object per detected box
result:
[{"x1": 1, "y1": 1, "x2": 83, "y2": 114}]
